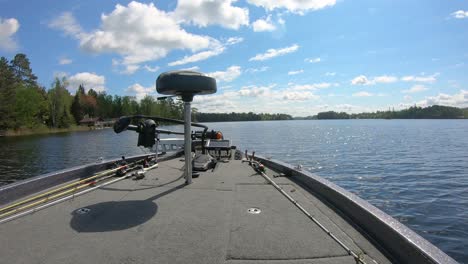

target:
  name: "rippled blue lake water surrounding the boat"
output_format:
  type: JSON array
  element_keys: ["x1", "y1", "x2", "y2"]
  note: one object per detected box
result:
[{"x1": 0, "y1": 120, "x2": 468, "y2": 263}]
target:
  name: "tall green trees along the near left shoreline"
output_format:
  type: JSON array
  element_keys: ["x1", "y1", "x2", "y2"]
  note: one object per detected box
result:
[{"x1": 0, "y1": 53, "x2": 183, "y2": 130}]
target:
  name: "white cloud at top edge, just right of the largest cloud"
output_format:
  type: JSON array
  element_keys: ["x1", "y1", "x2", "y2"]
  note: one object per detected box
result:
[{"x1": 174, "y1": 0, "x2": 249, "y2": 29}]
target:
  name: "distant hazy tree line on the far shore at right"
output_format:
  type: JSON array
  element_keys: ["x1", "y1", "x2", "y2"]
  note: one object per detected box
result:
[{"x1": 307, "y1": 105, "x2": 468, "y2": 119}]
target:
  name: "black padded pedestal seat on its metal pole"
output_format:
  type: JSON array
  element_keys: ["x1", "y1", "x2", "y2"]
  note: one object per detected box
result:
[{"x1": 156, "y1": 71, "x2": 217, "y2": 184}]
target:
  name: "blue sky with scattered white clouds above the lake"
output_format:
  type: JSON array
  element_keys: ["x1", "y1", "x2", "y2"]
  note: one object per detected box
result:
[{"x1": 0, "y1": 0, "x2": 468, "y2": 116}]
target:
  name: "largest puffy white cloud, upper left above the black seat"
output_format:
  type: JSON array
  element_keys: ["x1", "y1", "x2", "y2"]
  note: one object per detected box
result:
[{"x1": 49, "y1": 2, "x2": 220, "y2": 68}]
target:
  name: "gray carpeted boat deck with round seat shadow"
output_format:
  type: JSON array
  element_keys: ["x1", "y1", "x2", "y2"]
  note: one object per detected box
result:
[{"x1": 0, "y1": 159, "x2": 389, "y2": 264}]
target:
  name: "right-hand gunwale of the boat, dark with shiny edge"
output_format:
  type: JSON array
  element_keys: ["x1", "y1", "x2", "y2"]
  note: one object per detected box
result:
[{"x1": 255, "y1": 155, "x2": 458, "y2": 264}]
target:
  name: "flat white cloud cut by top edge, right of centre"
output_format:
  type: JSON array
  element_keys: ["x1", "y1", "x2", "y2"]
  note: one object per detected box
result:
[{"x1": 247, "y1": 0, "x2": 336, "y2": 14}]
